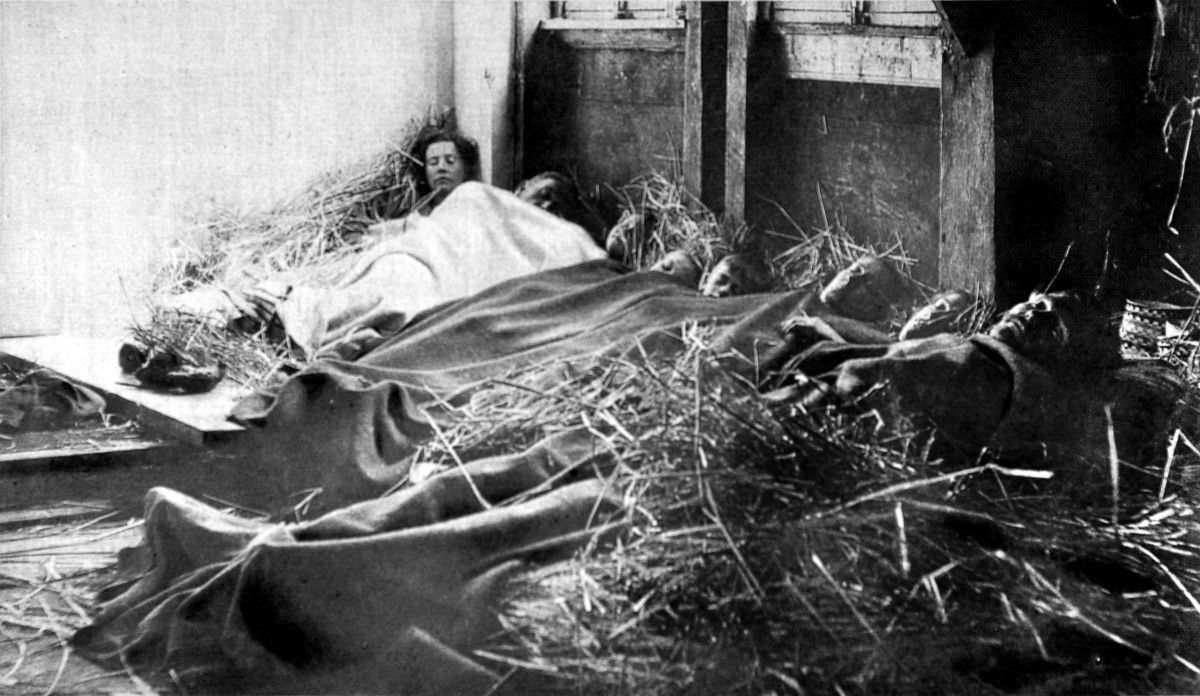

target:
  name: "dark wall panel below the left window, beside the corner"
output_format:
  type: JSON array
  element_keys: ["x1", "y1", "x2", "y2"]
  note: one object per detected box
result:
[{"x1": 523, "y1": 28, "x2": 684, "y2": 194}]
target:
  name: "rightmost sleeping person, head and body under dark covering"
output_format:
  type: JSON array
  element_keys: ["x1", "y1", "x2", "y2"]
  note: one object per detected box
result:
[{"x1": 764, "y1": 292, "x2": 1180, "y2": 456}]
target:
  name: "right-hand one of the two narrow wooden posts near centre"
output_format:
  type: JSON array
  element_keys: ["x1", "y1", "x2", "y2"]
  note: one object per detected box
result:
[{"x1": 725, "y1": 0, "x2": 750, "y2": 223}]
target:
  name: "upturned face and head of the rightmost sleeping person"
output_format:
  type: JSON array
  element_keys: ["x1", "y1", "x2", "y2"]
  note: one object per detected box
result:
[{"x1": 988, "y1": 293, "x2": 1081, "y2": 361}]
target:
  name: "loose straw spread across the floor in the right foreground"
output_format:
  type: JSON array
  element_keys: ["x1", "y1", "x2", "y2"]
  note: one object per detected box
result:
[{"x1": 412, "y1": 328, "x2": 1200, "y2": 694}]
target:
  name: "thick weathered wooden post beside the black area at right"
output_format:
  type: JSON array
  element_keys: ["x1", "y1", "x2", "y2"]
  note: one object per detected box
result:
[{"x1": 937, "y1": 41, "x2": 996, "y2": 296}]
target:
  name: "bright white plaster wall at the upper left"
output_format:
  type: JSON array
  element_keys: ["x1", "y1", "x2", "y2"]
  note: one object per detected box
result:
[{"x1": 0, "y1": 0, "x2": 451, "y2": 335}]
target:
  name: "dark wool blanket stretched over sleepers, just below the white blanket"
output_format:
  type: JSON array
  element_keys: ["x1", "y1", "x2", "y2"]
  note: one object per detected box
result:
[{"x1": 225, "y1": 262, "x2": 802, "y2": 508}]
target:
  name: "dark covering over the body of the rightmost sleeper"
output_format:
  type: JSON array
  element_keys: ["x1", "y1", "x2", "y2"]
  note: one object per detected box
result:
[{"x1": 767, "y1": 334, "x2": 1190, "y2": 462}]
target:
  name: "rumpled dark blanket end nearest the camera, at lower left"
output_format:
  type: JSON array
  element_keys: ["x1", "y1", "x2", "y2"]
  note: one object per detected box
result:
[{"x1": 74, "y1": 431, "x2": 624, "y2": 694}]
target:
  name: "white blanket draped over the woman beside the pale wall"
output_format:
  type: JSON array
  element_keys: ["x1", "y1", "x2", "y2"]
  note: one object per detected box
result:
[{"x1": 276, "y1": 182, "x2": 605, "y2": 359}]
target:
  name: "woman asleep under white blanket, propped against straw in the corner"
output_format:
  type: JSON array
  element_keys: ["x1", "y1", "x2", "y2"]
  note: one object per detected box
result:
[{"x1": 162, "y1": 176, "x2": 605, "y2": 360}]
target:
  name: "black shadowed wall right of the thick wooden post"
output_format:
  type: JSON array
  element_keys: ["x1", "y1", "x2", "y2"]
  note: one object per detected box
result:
[{"x1": 994, "y1": 2, "x2": 1176, "y2": 302}]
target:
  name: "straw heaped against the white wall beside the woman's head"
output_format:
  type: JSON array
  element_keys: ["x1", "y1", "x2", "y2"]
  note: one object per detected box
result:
[{"x1": 130, "y1": 112, "x2": 454, "y2": 388}]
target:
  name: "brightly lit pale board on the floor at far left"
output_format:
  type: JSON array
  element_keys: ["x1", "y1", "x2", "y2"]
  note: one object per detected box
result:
[{"x1": 0, "y1": 335, "x2": 247, "y2": 445}]
